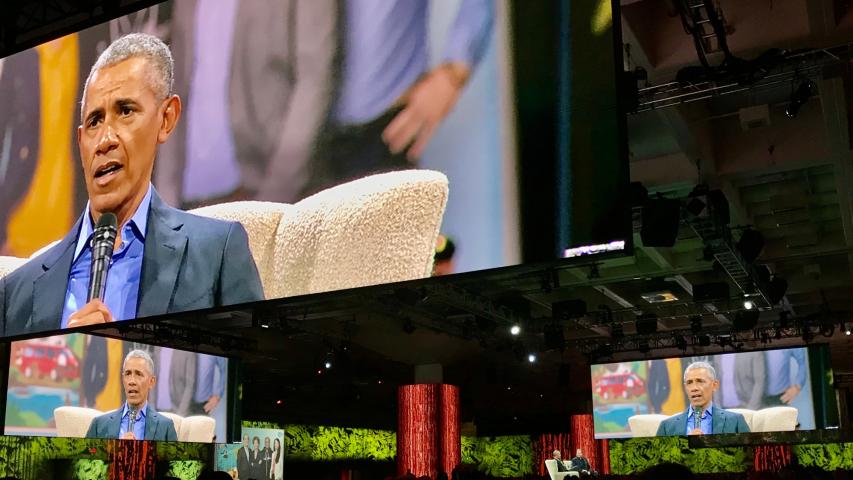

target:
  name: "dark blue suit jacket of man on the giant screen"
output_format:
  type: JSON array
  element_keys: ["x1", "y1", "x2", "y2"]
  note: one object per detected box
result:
[{"x1": 0, "y1": 190, "x2": 264, "y2": 335}]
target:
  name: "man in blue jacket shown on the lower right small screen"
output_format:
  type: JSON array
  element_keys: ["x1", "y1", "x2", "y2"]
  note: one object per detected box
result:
[{"x1": 657, "y1": 362, "x2": 749, "y2": 436}]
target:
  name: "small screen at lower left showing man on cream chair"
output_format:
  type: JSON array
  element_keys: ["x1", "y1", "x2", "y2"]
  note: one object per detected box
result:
[{"x1": 4, "y1": 333, "x2": 233, "y2": 442}]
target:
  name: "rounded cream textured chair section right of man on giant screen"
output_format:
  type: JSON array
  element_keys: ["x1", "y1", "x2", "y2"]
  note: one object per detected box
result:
[{"x1": 274, "y1": 170, "x2": 448, "y2": 297}]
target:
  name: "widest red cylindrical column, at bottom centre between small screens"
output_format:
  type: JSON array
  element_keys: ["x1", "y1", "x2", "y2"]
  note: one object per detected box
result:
[{"x1": 397, "y1": 384, "x2": 462, "y2": 478}]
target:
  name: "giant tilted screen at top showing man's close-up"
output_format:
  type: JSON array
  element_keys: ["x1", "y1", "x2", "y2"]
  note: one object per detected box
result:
[{"x1": 0, "y1": 0, "x2": 630, "y2": 336}]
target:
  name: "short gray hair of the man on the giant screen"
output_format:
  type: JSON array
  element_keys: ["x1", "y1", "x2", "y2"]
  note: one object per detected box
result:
[{"x1": 80, "y1": 33, "x2": 175, "y2": 116}]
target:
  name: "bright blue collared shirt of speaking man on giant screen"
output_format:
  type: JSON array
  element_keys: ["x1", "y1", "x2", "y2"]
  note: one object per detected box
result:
[{"x1": 61, "y1": 184, "x2": 151, "y2": 328}]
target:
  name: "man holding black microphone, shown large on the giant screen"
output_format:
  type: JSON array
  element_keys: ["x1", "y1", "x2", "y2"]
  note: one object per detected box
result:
[{"x1": 0, "y1": 34, "x2": 263, "y2": 335}]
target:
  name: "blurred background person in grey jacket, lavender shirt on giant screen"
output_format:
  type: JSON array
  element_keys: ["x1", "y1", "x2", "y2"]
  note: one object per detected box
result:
[{"x1": 155, "y1": 0, "x2": 338, "y2": 206}]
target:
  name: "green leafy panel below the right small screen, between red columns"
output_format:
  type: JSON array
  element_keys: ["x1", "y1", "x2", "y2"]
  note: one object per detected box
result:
[{"x1": 610, "y1": 437, "x2": 753, "y2": 475}]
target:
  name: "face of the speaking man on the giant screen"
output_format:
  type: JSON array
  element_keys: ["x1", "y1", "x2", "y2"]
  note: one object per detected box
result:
[{"x1": 77, "y1": 57, "x2": 168, "y2": 219}]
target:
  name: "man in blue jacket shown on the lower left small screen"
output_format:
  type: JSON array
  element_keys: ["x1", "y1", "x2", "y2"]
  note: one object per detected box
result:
[{"x1": 86, "y1": 350, "x2": 178, "y2": 441}]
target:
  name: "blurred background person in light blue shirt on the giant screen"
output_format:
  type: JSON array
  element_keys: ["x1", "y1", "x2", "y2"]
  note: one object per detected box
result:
[{"x1": 306, "y1": 0, "x2": 495, "y2": 194}]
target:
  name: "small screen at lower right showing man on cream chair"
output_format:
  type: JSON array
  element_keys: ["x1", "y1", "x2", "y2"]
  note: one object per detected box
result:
[{"x1": 590, "y1": 347, "x2": 835, "y2": 438}]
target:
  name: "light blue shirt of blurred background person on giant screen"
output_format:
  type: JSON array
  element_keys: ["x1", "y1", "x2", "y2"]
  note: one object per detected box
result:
[{"x1": 334, "y1": 0, "x2": 494, "y2": 125}]
